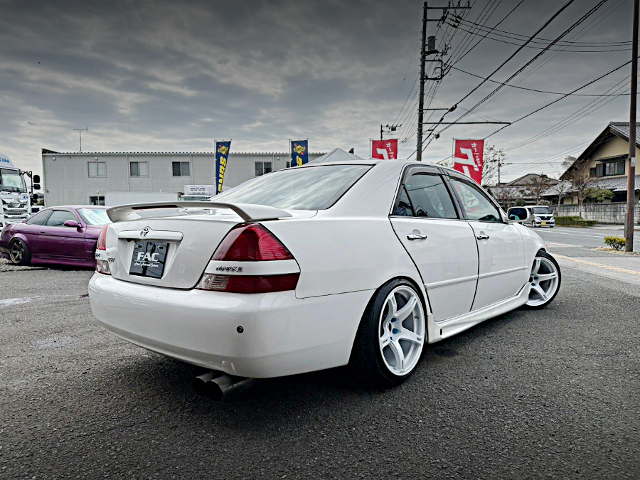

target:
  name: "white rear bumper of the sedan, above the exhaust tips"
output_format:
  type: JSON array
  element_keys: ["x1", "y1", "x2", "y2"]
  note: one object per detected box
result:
[{"x1": 89, "y1": 274, "x2": 373, "y2": 378}]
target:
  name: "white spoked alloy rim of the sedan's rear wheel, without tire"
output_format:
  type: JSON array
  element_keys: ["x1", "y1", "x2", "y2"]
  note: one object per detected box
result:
[{"x1": 378, "y1": 285, "x2": 426, "y2": 376}]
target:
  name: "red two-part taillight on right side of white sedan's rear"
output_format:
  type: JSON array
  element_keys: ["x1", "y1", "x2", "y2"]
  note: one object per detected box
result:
[{"x1": 196, "y1": 224, "x2": 300, "y2": 293}]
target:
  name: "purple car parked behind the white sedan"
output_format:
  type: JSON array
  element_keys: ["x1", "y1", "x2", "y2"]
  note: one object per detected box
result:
[{"x1": 0, "y1": 206, "x2": 110, "y2": 267}]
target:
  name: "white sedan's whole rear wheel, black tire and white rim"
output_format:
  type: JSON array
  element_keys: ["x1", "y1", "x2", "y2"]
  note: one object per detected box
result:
[{"x1": 349, "y1": 280, "x2": 427, "y2": 388}]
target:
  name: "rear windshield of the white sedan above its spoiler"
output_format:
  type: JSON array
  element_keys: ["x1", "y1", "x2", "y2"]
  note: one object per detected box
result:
[{"x1": 215, "y1": 165, "x2": 371, "y2": 210}]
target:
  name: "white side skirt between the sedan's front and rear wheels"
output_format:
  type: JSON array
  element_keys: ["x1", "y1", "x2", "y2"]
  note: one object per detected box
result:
[{"x1": 427, "y1": 282, "x2": 531, "y2": 343}]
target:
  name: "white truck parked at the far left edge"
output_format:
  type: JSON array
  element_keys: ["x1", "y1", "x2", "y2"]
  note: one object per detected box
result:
[{"x1": 0, "y1": 153, "x2": 40, "y2": 230}]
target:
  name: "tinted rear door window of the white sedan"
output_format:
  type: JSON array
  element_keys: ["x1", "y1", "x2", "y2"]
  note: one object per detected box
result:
[{"x1": 404, "y1": 173, "x2": 458, "y2": 218}]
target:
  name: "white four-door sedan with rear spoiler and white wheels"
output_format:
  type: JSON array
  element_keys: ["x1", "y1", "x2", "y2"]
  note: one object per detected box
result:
[{"x1": 89, "y1": 160, "x2": 561, "y2": 387}]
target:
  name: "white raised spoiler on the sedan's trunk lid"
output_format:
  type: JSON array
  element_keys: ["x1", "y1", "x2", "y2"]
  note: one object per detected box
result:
[{"x1": 107, "y1": 202, "x2": 291, "y2": 222}]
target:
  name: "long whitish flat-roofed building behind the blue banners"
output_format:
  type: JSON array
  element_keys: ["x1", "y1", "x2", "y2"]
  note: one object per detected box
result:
[{"x1": 42, "y1": 148, "x2": 323, "y2": 207}]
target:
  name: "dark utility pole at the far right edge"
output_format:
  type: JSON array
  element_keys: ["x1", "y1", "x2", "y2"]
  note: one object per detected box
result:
[{"x1": 625, "y1": 0, "x2": 640, "y2": 252}]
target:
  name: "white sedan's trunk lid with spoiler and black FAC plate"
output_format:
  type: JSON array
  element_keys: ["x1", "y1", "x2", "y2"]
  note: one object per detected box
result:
[{"x1": 106, "y1": 203, "x2": 317, "y2": 289}]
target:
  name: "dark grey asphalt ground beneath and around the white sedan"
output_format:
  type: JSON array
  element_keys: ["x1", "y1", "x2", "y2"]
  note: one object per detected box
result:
[{"x1": 0, "y1": 266, "x2": 640, "y2": 479}]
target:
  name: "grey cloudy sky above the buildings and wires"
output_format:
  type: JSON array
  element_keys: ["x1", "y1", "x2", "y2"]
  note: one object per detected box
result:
[{"x1": 0, "y1": 0, "x2": 633, "y2": 179}]
